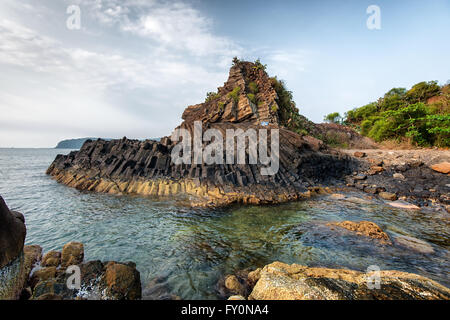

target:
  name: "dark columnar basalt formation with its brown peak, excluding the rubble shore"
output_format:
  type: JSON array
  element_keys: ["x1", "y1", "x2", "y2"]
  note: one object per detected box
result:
[{"x1": 47, "y1": 62, "x2": 355, "y2": 205}]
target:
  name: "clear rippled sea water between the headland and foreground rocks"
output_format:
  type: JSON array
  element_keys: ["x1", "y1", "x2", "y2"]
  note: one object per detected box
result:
[{"x1": 0, "y1": 149, "x2": 450, "y2": 299}]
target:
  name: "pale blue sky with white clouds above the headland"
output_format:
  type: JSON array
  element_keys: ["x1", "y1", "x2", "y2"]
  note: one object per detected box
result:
[{"x1": 0, "y1": 0, "x2": 450, "y2": 148}]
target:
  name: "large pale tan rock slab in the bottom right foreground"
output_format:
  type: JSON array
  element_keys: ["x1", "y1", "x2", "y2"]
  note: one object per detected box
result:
[{"x1": 237, "y1": 262, "x2": 450, "y2": 300}]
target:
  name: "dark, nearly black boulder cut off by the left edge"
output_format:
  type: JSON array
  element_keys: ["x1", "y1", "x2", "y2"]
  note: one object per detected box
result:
[{"x1": 0, "y1": 196, "x2": 27, "y2": 269}]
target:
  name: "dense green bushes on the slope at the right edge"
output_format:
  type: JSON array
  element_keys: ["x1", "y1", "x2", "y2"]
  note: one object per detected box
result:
[{"x1": 342, "y1": 81, "x2": 450, "y2": 147}]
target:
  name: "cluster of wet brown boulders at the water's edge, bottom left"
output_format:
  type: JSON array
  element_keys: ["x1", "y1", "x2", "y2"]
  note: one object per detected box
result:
[{"x1": 28, "y1": 242, "x2": 142, "y2": 300}]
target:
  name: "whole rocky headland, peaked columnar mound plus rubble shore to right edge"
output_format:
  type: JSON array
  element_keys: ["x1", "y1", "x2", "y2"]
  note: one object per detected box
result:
[{"x1": 47, "y1": 61, "x2": 450, "y2": 210}]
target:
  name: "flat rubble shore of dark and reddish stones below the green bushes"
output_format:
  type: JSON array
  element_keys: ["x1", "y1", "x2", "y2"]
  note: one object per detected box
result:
[{"x1": 343, "y1": 149, "x2": 450, "y2": 210}]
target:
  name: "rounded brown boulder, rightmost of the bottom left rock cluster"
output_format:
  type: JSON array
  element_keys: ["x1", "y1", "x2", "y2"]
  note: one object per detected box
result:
[{"x1": 105, "y1": 262, "x2": 141, "y2": 300}]
